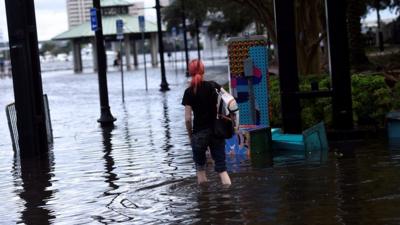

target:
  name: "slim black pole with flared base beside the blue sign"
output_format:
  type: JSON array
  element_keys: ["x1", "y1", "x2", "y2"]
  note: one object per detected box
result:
[{"x1": 93, "y1": 0, "x2": 116, "y2": 126}]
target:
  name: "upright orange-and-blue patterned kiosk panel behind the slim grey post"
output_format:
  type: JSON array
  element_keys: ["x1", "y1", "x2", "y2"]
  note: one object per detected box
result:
[{"x1": 228, "y1": 37, "x2": 270, "y2": 126}]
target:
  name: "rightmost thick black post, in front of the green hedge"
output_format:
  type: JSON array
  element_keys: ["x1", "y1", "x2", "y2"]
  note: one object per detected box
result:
[{"x1": 325, "y1": 0, "x2": 353, "y2": 130}]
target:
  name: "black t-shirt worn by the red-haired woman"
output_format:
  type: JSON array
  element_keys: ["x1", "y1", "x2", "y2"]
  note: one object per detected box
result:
[{"x1": 182, "y1": 81, "x2": 220, "y2": 133}]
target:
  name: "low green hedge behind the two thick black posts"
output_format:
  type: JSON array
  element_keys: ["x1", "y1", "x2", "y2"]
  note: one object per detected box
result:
[{"x1": 270, "y1": 74, "x2": 400, "y2": 128}]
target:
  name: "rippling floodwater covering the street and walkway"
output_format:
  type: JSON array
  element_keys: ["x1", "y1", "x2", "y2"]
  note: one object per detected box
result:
[{"x1": 0, "y1": 62, "x2": 400, "y2": 225}]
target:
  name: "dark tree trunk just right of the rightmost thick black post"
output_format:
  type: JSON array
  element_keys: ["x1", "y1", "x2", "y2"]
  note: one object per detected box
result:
[{"x1": 347, "y1": 0, "x2": 369, "y2": 71}]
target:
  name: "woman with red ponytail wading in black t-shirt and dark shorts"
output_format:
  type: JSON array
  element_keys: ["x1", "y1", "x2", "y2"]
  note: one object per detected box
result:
[{"x1": 182, "y1": 59, "x2": 231, "y2": 185}]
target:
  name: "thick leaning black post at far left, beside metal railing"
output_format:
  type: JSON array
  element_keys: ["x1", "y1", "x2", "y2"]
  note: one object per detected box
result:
[{"x1": 5, "y1": 0, "x2": 49, "y2": 158}]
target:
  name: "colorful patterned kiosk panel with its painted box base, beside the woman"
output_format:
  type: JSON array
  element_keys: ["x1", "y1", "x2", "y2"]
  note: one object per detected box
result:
[{"x1": 225, "y1": 36, "x2": 271, "y2": 157}]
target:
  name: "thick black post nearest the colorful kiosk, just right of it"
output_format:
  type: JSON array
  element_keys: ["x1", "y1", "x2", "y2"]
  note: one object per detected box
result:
[{"x1": 274, "y1": 0, "x2": 302, "y2": 133}]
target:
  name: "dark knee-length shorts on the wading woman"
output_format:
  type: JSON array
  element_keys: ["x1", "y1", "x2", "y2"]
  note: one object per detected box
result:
[{"x1": 191, "y1": 129, "x2": 226, "y2": 173}]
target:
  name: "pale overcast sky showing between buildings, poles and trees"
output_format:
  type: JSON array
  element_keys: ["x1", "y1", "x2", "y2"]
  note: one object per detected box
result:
[{"x1": 0, "y1": 0, "x2": 394, "y2": 41}]
